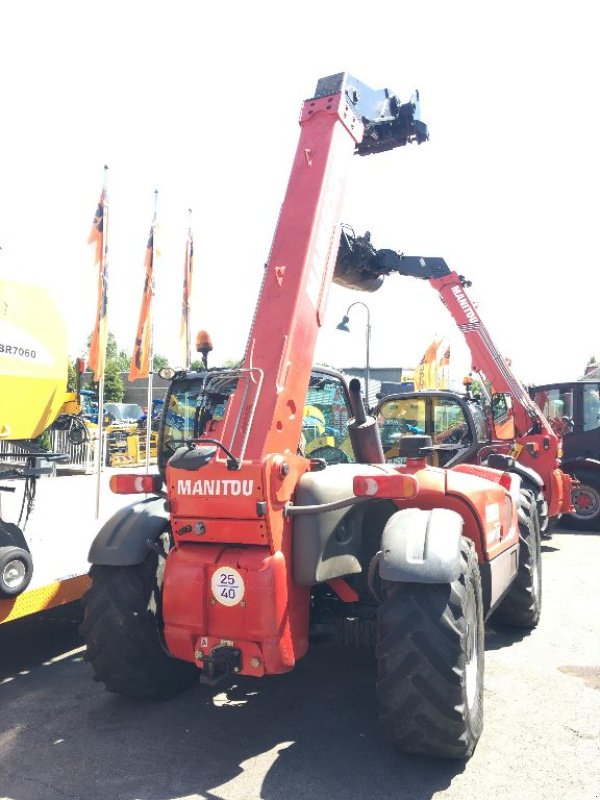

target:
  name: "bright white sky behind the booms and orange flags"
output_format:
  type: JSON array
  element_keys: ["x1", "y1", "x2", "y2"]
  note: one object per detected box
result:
[{"x1": 0, "y1": 0, "x2": 600, "y2": 382}]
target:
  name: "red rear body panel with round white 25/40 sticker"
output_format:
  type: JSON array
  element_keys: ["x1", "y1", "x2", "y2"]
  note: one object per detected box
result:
[{"x1": 163, "y1": 544, "x2": 309, "y2": 675}]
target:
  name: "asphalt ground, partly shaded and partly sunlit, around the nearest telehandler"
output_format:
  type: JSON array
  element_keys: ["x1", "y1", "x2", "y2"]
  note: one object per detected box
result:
[{"x1": 0, "y1": 490, "x2": 600, "y2": 800}]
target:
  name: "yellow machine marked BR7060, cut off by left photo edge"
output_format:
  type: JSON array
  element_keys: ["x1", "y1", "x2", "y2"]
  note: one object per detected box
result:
[{"x1": 0, "y1": 278, "x2": 85, "y2": 622}]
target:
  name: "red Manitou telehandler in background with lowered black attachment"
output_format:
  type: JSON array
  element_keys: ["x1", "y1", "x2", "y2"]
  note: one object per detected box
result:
[{"x1": 338, "y1": 229, "x2": 572, "y2": 536}]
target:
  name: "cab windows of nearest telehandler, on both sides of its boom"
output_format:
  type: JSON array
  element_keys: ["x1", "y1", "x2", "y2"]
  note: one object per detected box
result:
[{"x1": 158, "y1": 367, "x2": 356, "y2": 477}]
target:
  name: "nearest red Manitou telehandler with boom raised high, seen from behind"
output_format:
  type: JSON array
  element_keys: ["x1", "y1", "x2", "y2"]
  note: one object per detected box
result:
[{"x1": 82, "y1": 73, "x2": 541, "y2": 759}]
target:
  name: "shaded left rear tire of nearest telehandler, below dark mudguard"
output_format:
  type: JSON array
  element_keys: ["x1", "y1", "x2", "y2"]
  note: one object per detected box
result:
[{"x1": 80, "y1": 552, "x2": 200, "y2": 699}]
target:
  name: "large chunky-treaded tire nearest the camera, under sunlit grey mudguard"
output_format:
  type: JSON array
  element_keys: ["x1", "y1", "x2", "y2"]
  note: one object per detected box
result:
[{"x1": 376, "y1": 538, "x2": 484, "y2": 759}]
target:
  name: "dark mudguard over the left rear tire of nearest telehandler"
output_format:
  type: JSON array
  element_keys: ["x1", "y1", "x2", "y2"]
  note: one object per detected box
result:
[{"x1": 88, "y1": 497, "x2": 169, "y2": 567}]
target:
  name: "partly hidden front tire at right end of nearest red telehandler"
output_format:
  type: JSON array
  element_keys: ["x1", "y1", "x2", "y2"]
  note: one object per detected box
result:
[{"x1": 493, "y1": 491, "x2": 542, "y2": 628}]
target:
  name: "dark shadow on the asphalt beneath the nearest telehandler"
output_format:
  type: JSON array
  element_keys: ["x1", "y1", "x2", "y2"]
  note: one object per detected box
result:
[{"x1": 0, "y1": 626, "x2": 464, "y2": 800}]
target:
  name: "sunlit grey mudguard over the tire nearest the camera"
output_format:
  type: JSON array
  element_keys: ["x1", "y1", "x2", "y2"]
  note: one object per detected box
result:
[{"x1": 379, "y1": 508, "x2": 463, "y2": 583}]
